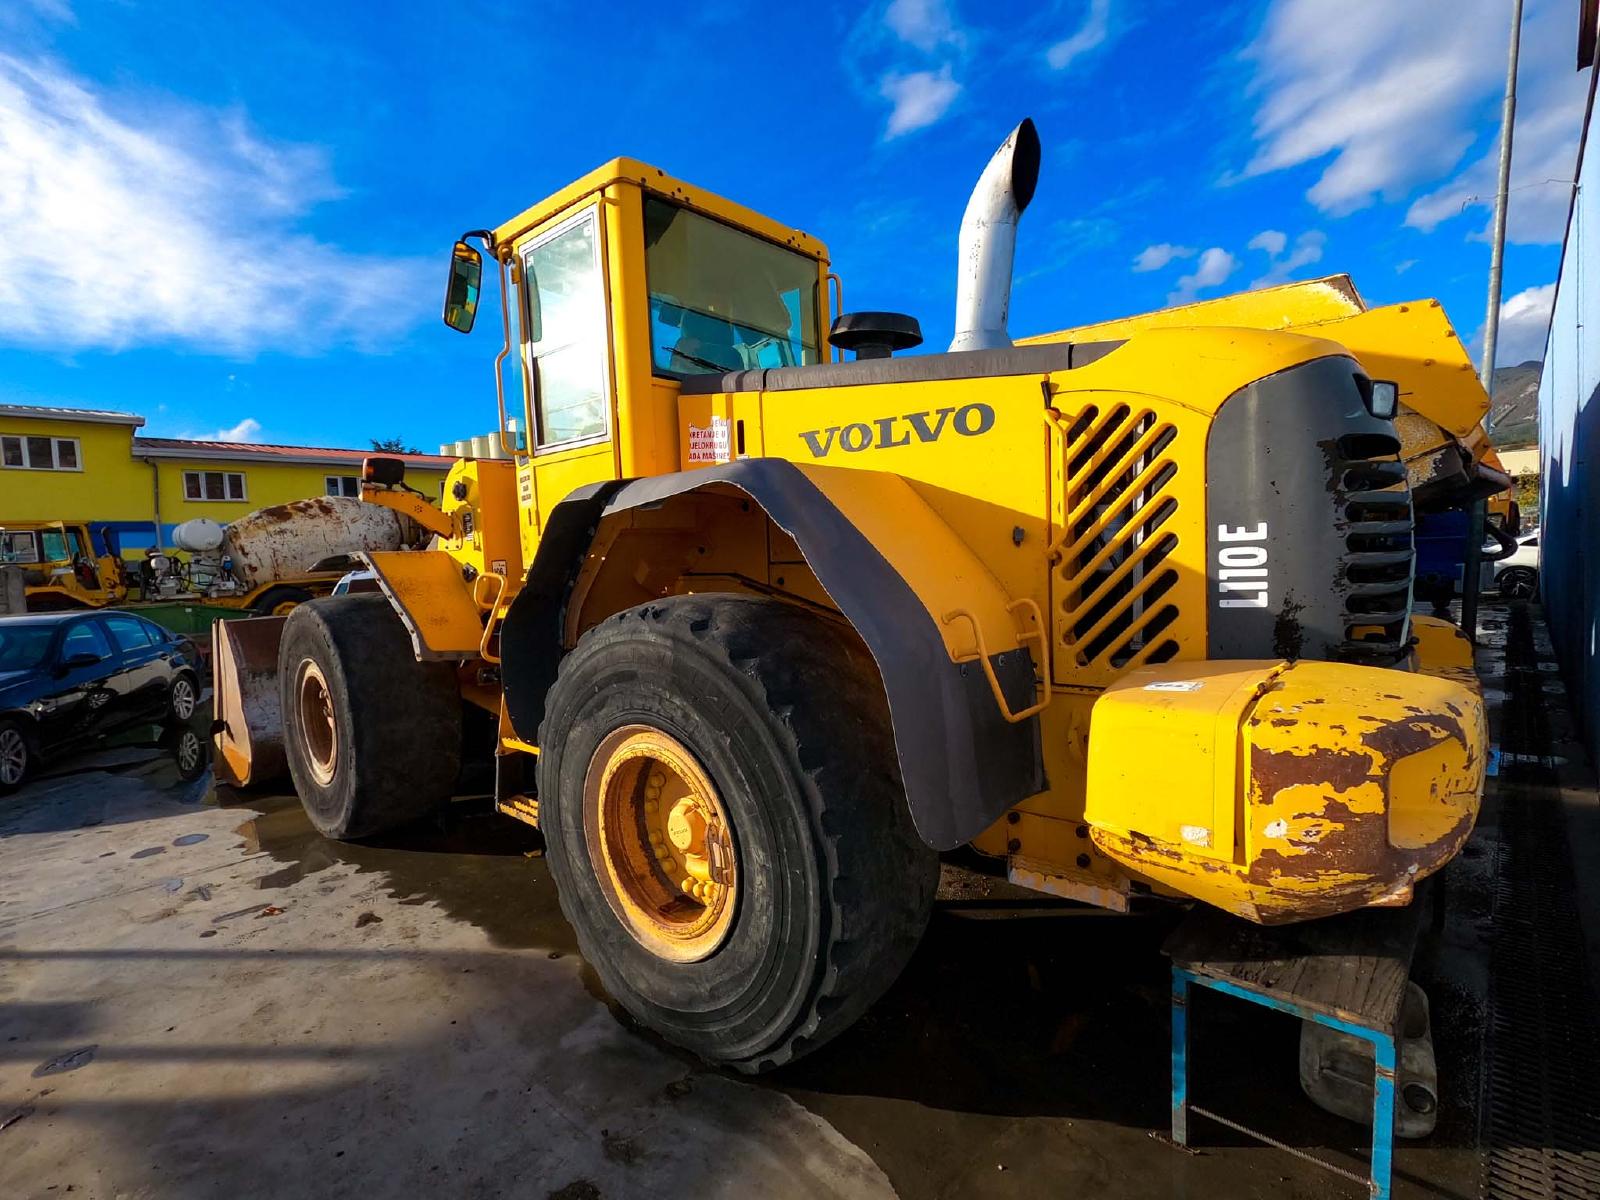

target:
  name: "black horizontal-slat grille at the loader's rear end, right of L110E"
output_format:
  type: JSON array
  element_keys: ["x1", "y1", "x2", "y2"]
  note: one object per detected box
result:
[{"x1": 1334, "y1": 434, "x2": 1416, "y2": 664}]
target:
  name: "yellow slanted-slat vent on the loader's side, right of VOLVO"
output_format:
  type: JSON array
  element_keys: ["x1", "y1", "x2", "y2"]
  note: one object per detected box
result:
[{"x1": 1051, "y1": 403, "x2": 1179, "y2": 670}]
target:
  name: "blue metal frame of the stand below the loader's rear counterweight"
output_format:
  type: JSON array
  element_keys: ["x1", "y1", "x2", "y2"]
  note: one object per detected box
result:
[{"x1": 1173, "y1": 966, "x2": 1395, "y2": 1200}]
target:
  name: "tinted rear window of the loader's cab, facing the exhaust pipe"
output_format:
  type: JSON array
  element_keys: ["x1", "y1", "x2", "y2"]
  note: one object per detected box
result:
[{"x1": 645, "y1": 197, "x2": 821, "y2": 376}]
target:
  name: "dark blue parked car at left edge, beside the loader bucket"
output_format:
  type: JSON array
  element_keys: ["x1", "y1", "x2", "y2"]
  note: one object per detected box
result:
[{"x1": 0, "y1": 610, "x2": 200, "y2": 794}]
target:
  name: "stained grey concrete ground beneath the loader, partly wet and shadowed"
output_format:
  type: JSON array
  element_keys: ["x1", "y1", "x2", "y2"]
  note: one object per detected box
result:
[{"x1": 0, "y1": 624, "x2": 1548, "y2": 1200}]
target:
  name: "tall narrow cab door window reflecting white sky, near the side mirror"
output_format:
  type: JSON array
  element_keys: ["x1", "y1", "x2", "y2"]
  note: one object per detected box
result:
[{"x1": 522, "y1": 210, "x2": 611, "y2": 450}]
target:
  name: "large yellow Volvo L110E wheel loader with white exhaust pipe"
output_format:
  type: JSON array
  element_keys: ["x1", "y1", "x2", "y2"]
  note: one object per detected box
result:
[{"x1": 224, "y1": 122, "x2": 1485, "y2": 1070}]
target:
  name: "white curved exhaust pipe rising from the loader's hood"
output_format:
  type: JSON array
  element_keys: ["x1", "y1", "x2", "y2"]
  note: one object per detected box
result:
[{"x1": 950, "y1": 120, "x2": 1038, "y2": 350}]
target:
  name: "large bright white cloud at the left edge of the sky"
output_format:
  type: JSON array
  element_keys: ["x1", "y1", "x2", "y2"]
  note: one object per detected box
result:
[{"x1": 0, "y1": 54, "x2": 434, "y2": 355}]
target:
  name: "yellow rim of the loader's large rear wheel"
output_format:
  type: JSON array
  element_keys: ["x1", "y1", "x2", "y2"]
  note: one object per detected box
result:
[{"x1": 584, "y1": 725, "x2": 739, "y2": 963}]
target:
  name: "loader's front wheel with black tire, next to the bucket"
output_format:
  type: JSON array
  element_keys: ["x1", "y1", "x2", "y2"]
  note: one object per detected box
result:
[{"x1": 278, "y1": 595, "x2": 461, "y2": 840}]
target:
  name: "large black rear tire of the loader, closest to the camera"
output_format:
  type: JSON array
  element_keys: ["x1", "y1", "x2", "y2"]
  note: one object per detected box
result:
[{"x1": 539, "y1": 595, "x2": 939, "y2": 1072}]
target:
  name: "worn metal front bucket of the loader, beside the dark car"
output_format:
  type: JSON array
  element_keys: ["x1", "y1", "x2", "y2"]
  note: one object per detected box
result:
[{"x1": 211, "y1": 616, "x2": 288, "y2": 787}]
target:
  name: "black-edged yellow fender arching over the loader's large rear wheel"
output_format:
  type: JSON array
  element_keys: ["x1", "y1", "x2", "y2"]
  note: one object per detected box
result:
[{"x1": 501, "y1": 459, "x2": 1045, "y2": 850}]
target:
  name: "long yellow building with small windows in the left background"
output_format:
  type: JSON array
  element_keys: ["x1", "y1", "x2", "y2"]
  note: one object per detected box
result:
[{"x1": 0, "y1": 405, "x2": 454, "y2": 554}]
